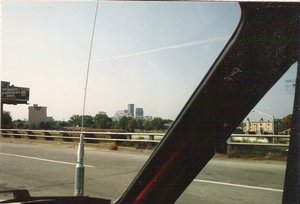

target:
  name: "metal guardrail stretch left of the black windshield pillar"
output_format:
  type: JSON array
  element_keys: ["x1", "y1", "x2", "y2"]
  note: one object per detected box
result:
[{"x1": 0, "y1": 129, "x2": 165, "y2": 143}]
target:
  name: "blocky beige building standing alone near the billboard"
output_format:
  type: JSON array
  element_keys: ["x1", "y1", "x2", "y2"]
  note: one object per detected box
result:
[{"x1": 28, "y1": 104, "x2": 47, "y2": 128}]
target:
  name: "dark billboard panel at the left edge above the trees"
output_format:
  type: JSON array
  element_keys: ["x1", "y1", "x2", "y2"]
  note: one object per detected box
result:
[{"x1": 1, "y1": 82, "x2": 29, "y2": 104}]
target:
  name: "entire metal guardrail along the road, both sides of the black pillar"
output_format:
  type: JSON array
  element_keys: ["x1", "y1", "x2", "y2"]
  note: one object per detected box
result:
[{"x1": 0, "y1": 129, "x2": 290, "y2": 147}]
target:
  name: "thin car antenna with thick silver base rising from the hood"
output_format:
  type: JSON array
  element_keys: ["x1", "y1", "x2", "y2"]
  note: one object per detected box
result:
[{"x1": 74, "y1": 0, "x2": 99, "y2": 196}]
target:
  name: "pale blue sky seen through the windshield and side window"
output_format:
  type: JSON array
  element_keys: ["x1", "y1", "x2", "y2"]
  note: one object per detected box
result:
[{"x1": 1, "y1": 0, "x2": 296, "y2": 120}]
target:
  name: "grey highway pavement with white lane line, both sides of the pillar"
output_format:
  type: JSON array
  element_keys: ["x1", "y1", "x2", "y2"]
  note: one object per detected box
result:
[{"x1": 0, "y1": 142, "x2": 285, "y2": 204}]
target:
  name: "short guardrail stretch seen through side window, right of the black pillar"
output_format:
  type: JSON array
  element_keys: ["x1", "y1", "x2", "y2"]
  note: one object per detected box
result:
[{"x1": 227, "y1": 134, "x2": 290, "y2": 147}]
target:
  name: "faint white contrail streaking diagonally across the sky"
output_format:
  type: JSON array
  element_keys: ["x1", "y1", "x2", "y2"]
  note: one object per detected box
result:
[{"x1": 93, "y1": 37, "x2": 227, "y2": 62}]
